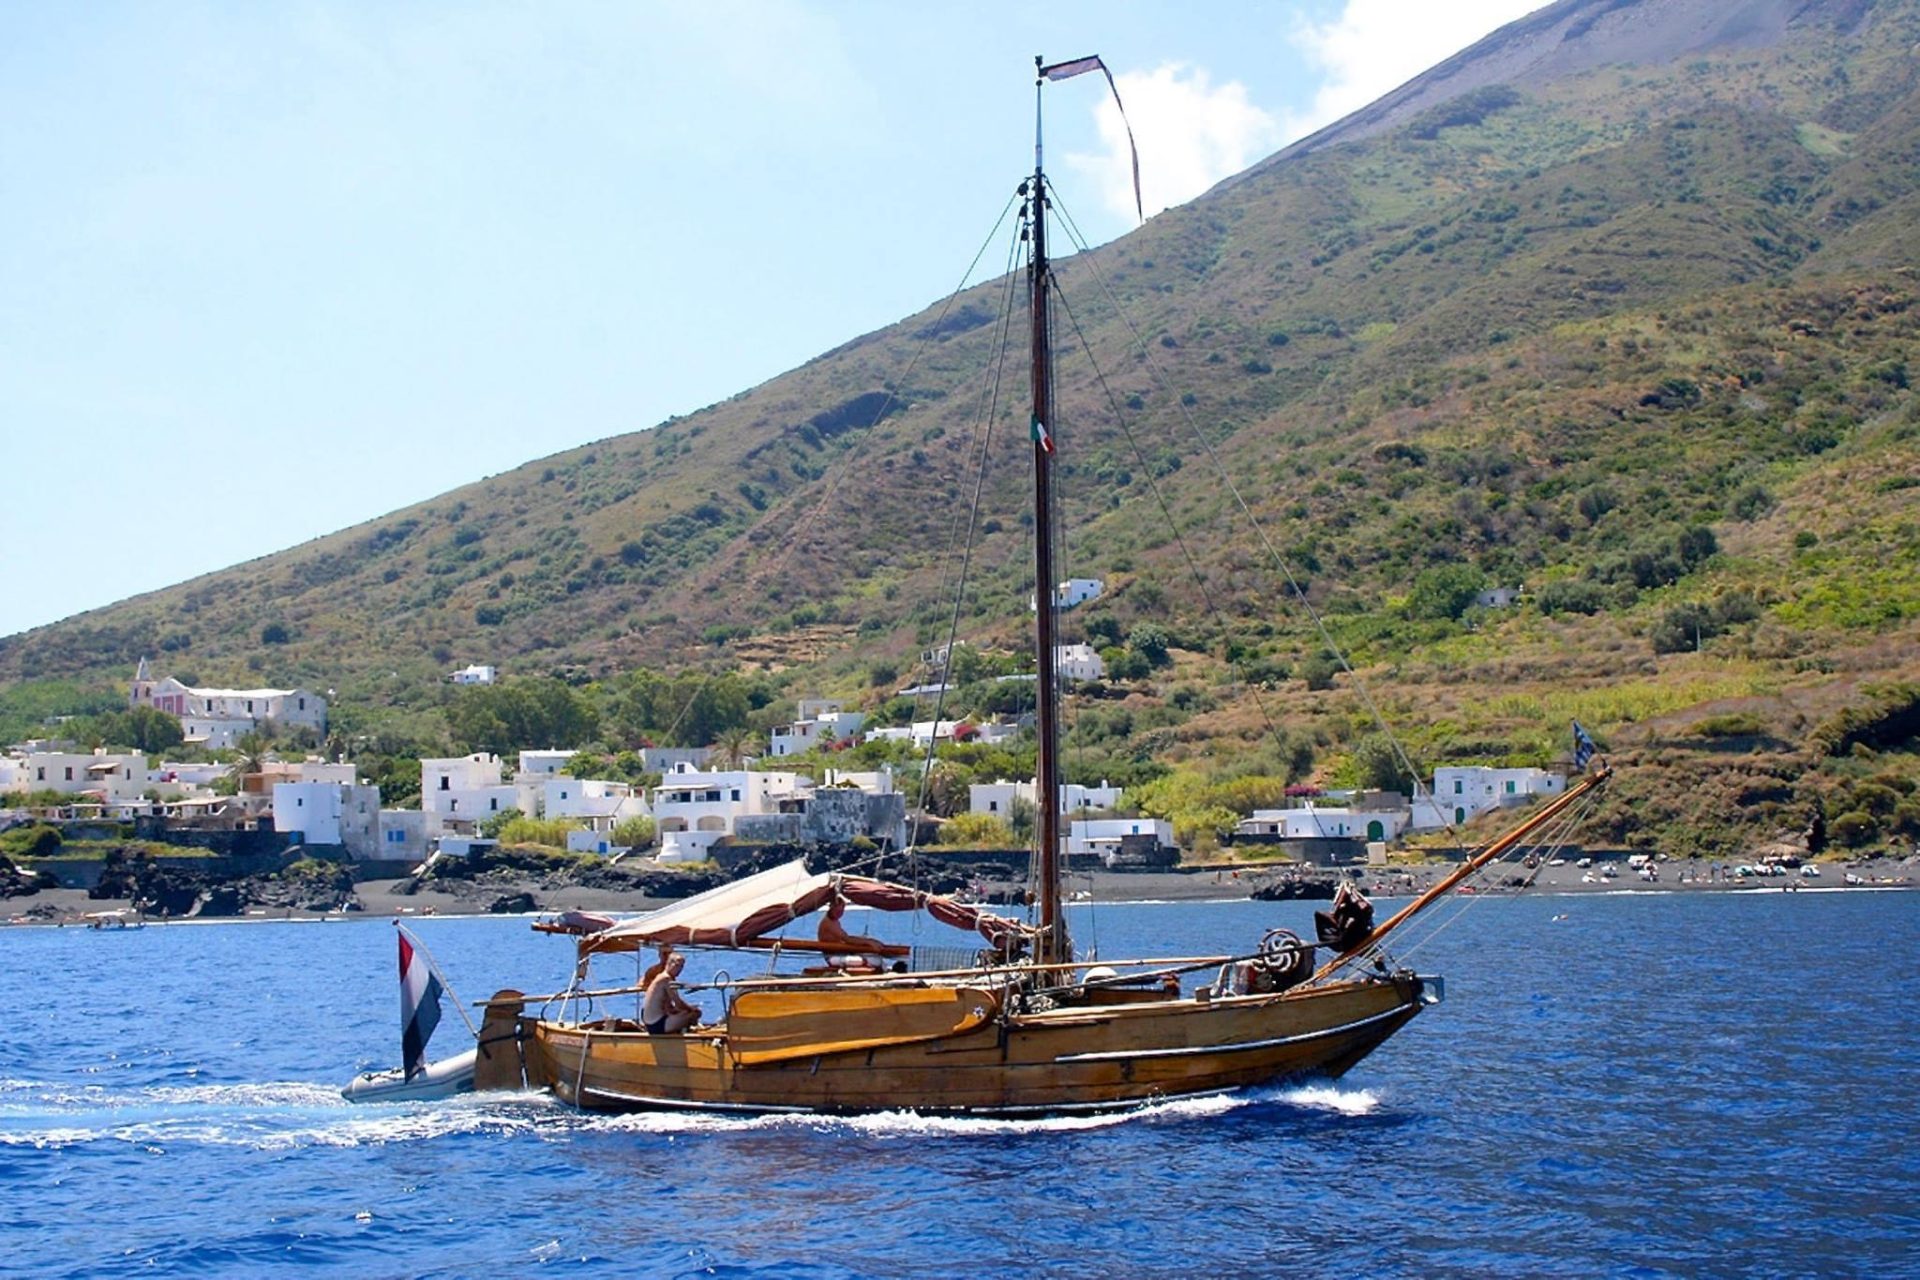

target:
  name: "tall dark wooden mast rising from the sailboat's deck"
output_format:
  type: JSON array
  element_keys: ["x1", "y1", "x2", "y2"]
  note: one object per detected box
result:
[{"x1": 1027, "y1": 58, "x2": 1073, "y2": 963}]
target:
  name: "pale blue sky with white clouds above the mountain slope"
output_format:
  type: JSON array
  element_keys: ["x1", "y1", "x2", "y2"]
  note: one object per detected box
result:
[{"x1": 0, "y1": 0, "x2": 1536, "y2": 635}]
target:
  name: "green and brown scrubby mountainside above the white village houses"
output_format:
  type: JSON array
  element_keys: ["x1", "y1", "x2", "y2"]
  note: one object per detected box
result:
[{"x1": 0, "y1": 0, "x2": 1920, "y2": 850}]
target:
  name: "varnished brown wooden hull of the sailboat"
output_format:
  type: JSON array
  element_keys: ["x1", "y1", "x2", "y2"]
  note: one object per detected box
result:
[{"x1": 520, "y1": 975, "x2": 1432, "y2": 1115}]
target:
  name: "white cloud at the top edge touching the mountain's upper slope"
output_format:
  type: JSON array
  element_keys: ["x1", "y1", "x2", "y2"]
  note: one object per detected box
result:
[{"x1": 1286, "y1": 0, "x2": 1542, "y2": 140}]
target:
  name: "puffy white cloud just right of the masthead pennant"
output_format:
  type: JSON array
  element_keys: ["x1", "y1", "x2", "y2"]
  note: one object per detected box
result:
[{"x1": 1068, "y1": 63, "x2": 1281, "y2": 223}]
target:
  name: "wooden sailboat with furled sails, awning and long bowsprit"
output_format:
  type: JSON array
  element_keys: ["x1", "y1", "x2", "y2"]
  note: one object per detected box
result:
[{"x1": 476, "y1": 59, "x2": 1605, "y2": 1115}]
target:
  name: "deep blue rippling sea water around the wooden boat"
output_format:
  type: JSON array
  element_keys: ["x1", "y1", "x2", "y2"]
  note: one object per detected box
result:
[{"x1": 0, "y1": 890, "x2": 1920, "y2": 1278}]
